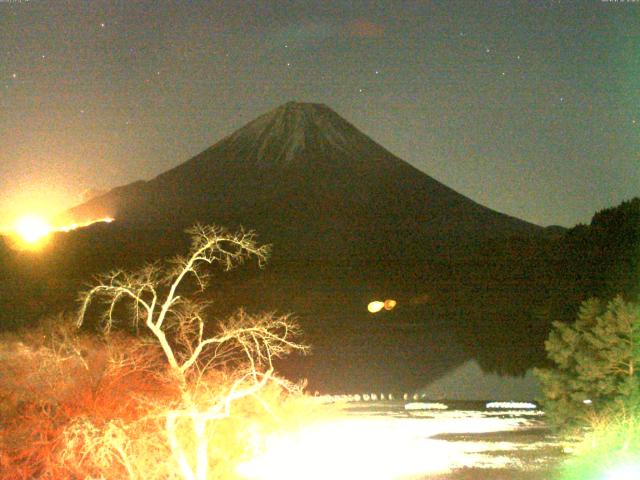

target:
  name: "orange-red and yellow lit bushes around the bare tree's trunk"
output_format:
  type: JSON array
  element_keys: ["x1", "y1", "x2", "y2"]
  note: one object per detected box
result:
[{"x1": 0, "y1": 316, "x2": 318, "y2": 479}]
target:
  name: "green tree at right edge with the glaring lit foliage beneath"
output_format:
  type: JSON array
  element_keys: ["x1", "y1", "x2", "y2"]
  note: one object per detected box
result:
[{"x1": 536, "y1": 296, "x2": 640, "y2": 480}]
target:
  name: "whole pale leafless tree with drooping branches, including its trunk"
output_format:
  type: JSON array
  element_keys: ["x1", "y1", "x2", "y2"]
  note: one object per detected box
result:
[{"x1": 78, "y1": 225, "x2": 308, "y2": 479}]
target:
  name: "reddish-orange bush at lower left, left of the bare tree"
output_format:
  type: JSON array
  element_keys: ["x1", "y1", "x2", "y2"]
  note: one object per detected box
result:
[{"x1": 0, "y1": 318, "x2": 179, "y2": 478}]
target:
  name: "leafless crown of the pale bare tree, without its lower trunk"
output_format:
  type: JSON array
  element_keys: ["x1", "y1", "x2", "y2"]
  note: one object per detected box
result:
[{"x1": 78, "y1": 225, "x2": 306, "y2": 383}]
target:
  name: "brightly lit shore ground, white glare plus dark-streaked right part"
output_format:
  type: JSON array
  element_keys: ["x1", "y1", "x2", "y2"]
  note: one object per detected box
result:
[{"x1": 239, "y1": 401, "x2": 561, "y2": 480}]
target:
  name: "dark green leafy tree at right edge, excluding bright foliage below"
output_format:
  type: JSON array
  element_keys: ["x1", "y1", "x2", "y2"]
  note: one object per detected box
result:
[{"x1": 536, "y1": 296, "x2": 640, "y2": 426}]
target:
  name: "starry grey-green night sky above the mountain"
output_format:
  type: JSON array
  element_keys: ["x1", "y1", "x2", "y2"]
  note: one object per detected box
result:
[{"x1": 0, "y1": 0, "x2": 640, "y2": 226}]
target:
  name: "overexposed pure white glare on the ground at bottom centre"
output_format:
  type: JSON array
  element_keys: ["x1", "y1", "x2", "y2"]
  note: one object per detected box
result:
[{"x1": 236, "y1": 410, "x2": 528, "y2": 480}]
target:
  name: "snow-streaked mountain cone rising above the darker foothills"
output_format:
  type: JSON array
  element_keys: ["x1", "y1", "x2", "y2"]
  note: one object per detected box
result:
[{"x1": 68, "y1": 102, "x2": 542, "y2": 257}]
